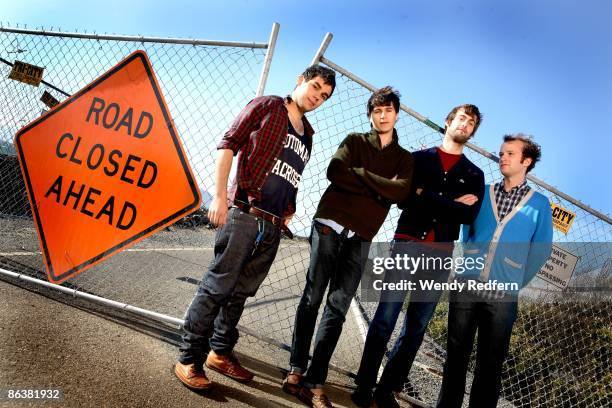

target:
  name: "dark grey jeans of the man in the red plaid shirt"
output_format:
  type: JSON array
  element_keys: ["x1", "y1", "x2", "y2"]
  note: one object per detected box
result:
[{"x1": 179, "y1": 208, "x2": 280, "y2": 364}]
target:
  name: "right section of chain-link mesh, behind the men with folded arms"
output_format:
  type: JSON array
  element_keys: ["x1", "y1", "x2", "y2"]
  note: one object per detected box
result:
[{"x1": 300, "y1": 65, "x2": 612, "y2": 407}]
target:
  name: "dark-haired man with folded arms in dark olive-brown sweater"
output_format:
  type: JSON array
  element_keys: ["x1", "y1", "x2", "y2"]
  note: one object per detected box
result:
[{"x1": 283, "y1": 87, "x2": 413, "y2": 407}]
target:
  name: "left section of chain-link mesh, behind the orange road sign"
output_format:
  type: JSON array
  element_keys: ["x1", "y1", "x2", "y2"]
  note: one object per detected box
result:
[{"x1": 0, "y1": 28, "x2": 267, "y2": 324}]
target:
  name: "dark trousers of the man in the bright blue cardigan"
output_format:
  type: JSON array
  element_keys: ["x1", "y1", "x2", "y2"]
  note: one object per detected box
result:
[{"x1": 437, "y1": 291, "x2": 518, "y2": 408}]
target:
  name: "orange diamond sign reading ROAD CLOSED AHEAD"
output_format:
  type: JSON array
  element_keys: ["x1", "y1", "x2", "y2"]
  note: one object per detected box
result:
[{"x1": 15, "y1": 51, "x2": 201, "y2": 283}]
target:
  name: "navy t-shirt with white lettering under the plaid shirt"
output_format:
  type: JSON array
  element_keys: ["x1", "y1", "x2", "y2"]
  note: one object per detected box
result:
[{"x1": 258, "y1": 122, "x2": 310, "y2": 217}]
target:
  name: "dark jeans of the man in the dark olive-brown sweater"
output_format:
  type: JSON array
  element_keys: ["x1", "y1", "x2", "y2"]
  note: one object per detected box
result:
[{"x1": 289, "y1": 221, "x2": 369, "y2": 388}]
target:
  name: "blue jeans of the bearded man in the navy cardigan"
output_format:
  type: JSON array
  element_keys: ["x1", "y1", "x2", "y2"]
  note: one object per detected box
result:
[{"x1": 355, "y1": 242, "x2": 450, "y2": 392}]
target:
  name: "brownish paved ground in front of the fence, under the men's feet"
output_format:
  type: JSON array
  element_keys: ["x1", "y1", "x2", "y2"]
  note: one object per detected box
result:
[{"x1": 0, "y1": 281, "x2": 368, "y2": 408}]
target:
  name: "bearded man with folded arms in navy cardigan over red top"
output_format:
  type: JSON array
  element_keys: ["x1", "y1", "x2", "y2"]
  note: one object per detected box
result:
[{"x1": 351, "y1": 104, "x2": 484, "y2": 408}]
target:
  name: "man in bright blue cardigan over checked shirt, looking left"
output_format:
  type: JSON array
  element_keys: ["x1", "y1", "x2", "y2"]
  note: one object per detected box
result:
[{"x1": 437, "y1": 134, "x2": 552, "y2": 407}]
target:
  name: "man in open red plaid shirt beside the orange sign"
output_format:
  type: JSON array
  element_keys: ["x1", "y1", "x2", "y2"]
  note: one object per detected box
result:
[{"x1": 174, "y1": 65, "x2": 336, "y2": 390}]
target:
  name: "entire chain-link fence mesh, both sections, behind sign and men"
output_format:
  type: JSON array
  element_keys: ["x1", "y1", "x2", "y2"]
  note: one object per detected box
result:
[{"x1": 0, "y1": 24, "x2": 612, "y2": 407}]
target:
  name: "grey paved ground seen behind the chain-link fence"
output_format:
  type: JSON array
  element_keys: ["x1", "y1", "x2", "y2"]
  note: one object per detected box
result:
[{"x1": 0, "y1": 218, "x2": 382, "y2": 394}]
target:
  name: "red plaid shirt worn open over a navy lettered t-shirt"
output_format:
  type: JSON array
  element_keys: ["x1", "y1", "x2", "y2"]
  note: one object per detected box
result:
[{"x1": 217, "y1": 96, "x2": 314, "y2": 215}]
